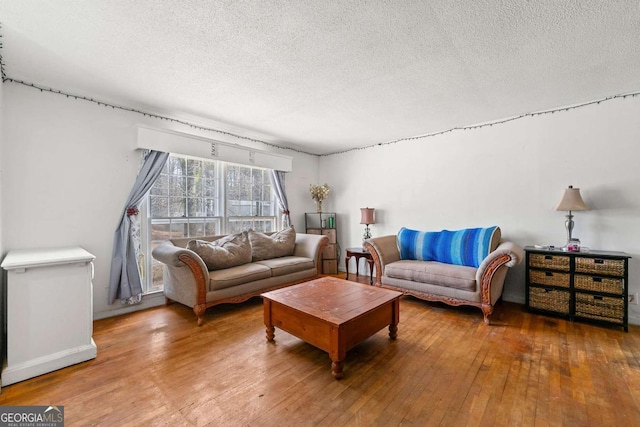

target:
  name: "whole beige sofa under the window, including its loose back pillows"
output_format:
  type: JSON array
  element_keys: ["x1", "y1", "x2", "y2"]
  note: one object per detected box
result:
[{"x1": 152, "y1": 228, "x2": 328, "y2": 326}]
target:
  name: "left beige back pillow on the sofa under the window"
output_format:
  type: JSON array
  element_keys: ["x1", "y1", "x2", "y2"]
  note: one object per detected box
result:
[{"x1": 187, "y1": 231, "x2": 251, "y2": 270}]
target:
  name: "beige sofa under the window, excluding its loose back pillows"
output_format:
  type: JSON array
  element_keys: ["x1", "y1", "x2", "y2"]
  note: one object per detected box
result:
[{"x1": 152, "y1": 232, "x2": 327, "y2": 326}]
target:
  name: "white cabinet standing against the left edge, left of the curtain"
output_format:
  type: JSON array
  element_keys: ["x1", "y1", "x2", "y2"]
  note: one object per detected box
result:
[{"x1": 1, "y1": 247, "x2": 97, "y2": 386}]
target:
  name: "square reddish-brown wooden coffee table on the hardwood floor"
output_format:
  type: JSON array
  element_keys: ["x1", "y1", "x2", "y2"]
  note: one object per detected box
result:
[{"x1": 261, "y1": 277, "x2": 402, "y2": 379}]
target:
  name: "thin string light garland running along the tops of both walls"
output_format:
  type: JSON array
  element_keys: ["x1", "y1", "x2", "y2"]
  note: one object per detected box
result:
[{"x1": 0, "y1": 25, "x2": 640, "y2": 157}]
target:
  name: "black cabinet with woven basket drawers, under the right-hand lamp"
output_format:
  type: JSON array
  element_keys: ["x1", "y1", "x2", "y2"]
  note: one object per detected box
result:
[{"x1": 524, "y1": 246, "x2": 631, "y2": 332}]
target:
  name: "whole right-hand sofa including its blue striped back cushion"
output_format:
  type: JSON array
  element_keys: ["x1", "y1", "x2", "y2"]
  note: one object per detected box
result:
[{"x1": 364, "y1": 227, "x2": 524, "y2": 324}]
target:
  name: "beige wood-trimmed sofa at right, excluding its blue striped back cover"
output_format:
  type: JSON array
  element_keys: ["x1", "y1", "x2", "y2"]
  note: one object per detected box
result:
[{"x1": 364, "y1": 231, "x2": 524, "y2": 324}]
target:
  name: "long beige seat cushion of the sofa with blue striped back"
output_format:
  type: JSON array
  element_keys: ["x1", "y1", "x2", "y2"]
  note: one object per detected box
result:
[{"x1": 384, "y1": 260, "x2": 477, "y2": 292}]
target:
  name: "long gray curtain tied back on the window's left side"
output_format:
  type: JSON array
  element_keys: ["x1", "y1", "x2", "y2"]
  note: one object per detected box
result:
[{"x1": 109, "y1": 151, "x2": 169, "y2": 304}]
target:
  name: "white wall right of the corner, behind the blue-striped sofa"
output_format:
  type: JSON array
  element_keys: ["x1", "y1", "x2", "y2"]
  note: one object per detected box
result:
[{"x1": 319, "y1": 97, "x2": 640, "y2": 324}]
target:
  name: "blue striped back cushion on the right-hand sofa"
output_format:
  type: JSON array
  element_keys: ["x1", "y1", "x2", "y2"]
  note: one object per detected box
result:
[{"x1": 397, "y1": 226, "x2": 501, "y2": 267}]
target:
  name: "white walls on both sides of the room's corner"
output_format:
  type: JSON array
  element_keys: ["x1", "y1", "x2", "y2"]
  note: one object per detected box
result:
[{"x1": 0, "y1": 83, "x2": 640, "y2": 324}]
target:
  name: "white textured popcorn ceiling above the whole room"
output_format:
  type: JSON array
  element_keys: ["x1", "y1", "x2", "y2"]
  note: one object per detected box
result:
[{"x1": 0, "y1": 0, "x2": 640, "y2": 154}]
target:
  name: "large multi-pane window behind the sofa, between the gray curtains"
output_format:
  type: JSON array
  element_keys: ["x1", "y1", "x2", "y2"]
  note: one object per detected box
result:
[{"x1": 143, "y1": 155, "x2": 276, "y2": 293}]
